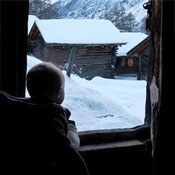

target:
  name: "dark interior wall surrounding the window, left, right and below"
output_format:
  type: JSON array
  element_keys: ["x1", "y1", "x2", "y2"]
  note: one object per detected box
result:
[{"x1": 0, "y1": 0, "x2": 175, "y2": 175}]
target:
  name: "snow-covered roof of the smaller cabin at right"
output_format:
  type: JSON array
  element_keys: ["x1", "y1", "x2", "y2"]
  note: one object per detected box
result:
[{"x1": 117, "y1": 32, "x2": 148, "y2": 56}]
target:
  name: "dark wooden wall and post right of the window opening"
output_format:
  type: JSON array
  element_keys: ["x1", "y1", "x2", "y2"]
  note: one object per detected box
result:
[{"x1": 147, "y1": 0, "x2": 175, "y2": 175}]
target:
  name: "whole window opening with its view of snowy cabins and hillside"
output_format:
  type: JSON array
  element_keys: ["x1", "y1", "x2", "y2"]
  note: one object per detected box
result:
[{"x1": 26, "y1": 0, "x2": 149, "y2": 131}]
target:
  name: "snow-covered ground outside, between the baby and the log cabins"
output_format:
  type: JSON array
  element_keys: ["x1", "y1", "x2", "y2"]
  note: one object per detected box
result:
[{"x1": 26, "y1": 56, "x2": 146, "y2": 131}]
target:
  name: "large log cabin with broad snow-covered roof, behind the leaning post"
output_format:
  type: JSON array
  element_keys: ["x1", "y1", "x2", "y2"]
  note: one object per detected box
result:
[{"x1": 28, "y1": 20, "x2": 122, "y2": 79}]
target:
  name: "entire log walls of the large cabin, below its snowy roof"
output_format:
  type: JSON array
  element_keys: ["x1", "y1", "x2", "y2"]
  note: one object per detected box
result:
[{"x1": 28, "y1": 32, "x2": 115, "y2": 79}]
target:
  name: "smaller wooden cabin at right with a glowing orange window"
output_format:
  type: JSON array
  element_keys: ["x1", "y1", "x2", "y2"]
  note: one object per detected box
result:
[{"x1": 115, "y1": 33, "x2": 150, "y2": 80}]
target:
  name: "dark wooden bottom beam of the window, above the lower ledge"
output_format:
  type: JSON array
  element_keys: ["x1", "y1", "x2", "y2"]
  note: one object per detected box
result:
[{"x1": 78, "y1": 125, "x2": 150, "y2": 146}]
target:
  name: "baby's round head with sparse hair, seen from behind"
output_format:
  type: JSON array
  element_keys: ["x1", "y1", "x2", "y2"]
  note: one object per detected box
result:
[{"x1": 27, "y1": 63, "x2": 65, "y2": 104}]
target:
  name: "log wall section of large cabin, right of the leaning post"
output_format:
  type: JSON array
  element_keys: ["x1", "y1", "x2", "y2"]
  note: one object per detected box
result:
[{"x1": 73, "y1": 46, "x2": 113, "y2": 79}]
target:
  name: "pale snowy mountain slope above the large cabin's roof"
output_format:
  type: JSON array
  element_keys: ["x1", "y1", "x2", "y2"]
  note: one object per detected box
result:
[{"x1": 53, "y1": 0, "x2": 147, "y2": 22}]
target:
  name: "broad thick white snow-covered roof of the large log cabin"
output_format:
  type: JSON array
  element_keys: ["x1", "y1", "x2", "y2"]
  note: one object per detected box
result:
[{"x1": 35, "y1": 19, "x2": 126, "y2": 44}]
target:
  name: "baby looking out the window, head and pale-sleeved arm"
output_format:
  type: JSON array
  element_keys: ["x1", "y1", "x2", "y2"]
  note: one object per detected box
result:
[{"x1": 27, "y1": 62, "x2": 80, "y2": 148}]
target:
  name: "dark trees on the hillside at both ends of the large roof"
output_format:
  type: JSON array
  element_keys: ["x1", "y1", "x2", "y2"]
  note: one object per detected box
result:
[{"x1": 29, "y1": 0, "x2": 145, "y2": 33}]
